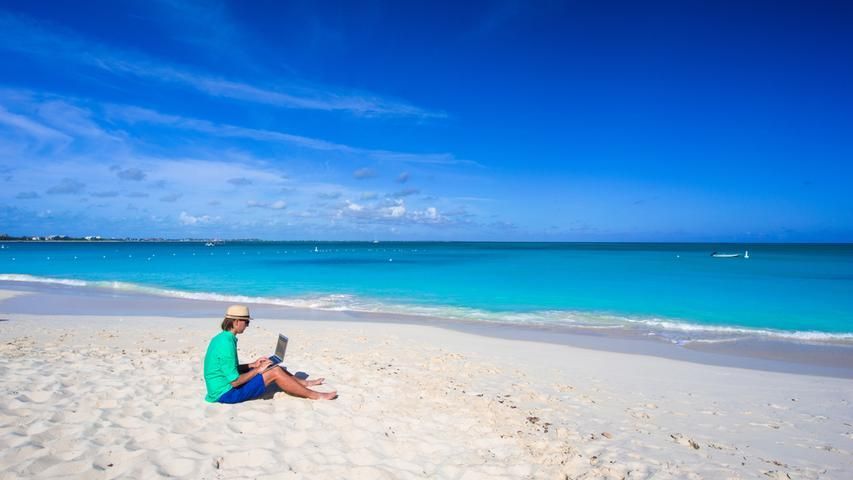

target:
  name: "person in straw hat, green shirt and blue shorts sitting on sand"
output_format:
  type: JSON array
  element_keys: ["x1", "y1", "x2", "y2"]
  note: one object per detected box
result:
[{"x1": 204, "y1": 305, "x2": 338, "y2": 403}]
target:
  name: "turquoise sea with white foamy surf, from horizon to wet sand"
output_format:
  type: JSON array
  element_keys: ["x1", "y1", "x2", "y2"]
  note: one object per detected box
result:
[{"x1": 0, "y1": 242, "x2": 853, "y2": 342}]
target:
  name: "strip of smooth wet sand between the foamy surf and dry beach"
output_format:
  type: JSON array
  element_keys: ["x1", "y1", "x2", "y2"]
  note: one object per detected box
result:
[{"x1": 0, "y1": 281, "x2": 853, "y2": 379}]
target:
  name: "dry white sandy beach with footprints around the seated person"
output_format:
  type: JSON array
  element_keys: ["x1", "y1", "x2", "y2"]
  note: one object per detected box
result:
[{"x1": 0, "y1": 295, "x2": 853, "y2": 479}]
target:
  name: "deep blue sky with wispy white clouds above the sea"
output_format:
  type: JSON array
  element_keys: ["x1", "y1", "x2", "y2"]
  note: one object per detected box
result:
[{"x1": 0, "y1": 0, "x2": 853, "y2": 242}]
